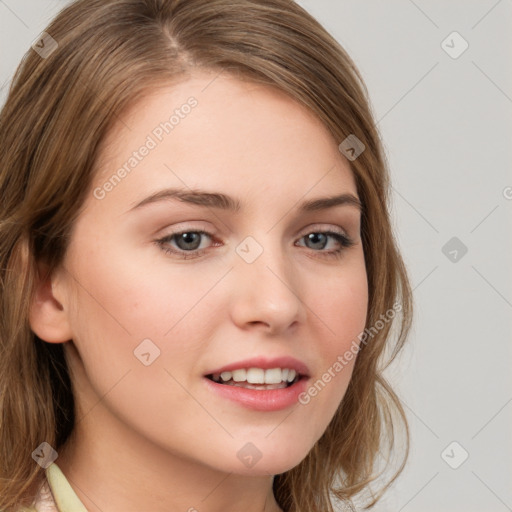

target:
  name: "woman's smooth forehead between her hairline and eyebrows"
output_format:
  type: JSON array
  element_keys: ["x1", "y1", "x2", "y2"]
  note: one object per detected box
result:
[{"x1": 88, "y1": 72, "x2": 356, "y2": 214}]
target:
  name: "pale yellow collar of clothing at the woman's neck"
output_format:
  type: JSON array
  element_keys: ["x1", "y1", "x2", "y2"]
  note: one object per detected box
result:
[{"x1": 18, "y1": 462, "x2": 87, "y2": 512}]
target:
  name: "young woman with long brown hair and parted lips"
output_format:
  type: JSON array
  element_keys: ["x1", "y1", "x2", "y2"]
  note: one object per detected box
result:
[{"x1": 0, "y1": 0, "x2": 412, "y2": 512}]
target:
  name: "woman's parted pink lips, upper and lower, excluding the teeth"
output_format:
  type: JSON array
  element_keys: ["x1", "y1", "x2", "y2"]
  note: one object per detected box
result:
[{"x1": 203, "y1": 356, "x2": 309, "y2": 412}]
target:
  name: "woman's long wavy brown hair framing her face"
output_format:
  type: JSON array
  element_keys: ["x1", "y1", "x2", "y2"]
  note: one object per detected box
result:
[{"x1": 0, "y1": 0, "x2": 412, "y2": 512}]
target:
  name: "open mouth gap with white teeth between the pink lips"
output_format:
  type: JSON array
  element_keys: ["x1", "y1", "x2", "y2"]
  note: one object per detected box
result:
[{"x1": 206, "y1": 367, "x2": 305, "y2": 390}]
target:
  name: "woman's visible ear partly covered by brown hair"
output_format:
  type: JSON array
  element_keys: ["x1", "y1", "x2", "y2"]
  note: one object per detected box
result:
[{"x1": 29, "y1": 264, "x2": 72, "y2": 343}]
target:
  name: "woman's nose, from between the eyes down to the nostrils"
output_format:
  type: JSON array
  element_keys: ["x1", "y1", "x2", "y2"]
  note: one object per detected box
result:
[{"x1": 233, "y1": 232, "x2": 304, "y2": 330}]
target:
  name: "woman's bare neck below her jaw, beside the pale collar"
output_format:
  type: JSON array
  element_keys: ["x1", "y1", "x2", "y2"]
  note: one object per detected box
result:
[{"x1": 56, "y1": 412, "x2": 282, "y2": 512}]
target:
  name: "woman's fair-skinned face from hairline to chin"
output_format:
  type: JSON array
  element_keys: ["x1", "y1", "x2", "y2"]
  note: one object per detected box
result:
[{"x1": 53, "y1": 73, "x2": 368, "y2": 475}]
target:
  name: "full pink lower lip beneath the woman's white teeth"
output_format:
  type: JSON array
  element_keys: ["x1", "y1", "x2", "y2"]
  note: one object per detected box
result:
[{"x1": 204, "y1": 377, "x2": 308, "y2": 411}]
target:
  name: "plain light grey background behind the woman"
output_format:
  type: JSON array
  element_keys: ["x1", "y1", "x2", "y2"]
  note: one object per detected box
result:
[{"x1": 0, "y1": 0, "x2": 512, "y2": 512}]
